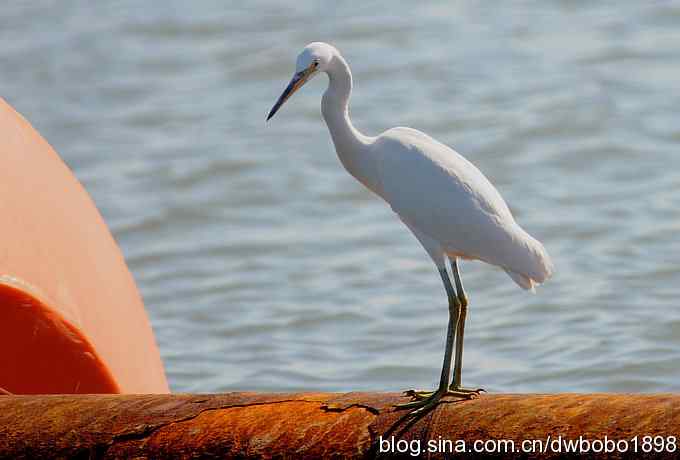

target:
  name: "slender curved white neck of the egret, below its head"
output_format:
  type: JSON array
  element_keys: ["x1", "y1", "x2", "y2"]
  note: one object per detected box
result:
[{"x1": 321, "y1": 54, "x2": 380, "y2": 194}]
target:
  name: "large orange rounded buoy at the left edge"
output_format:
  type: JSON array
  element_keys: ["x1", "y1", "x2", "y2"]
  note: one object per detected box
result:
[{"x1": 0, "y1": 98, "x2": 169, "y2": 394}]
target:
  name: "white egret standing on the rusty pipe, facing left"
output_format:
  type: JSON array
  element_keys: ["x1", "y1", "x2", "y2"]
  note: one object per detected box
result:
[{"x1": 267, "y1": 42, "x2": 552, "y2": 412}]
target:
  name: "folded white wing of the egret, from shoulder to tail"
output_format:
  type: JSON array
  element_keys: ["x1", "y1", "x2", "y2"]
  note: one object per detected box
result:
[{"x1": 375, "y1": 128, "x2": 547, "y2": 282}]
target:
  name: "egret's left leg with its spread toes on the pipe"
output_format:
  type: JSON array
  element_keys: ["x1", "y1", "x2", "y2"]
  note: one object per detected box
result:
[{"x1": 397, "y1": 268, "x2": 474, "y2": 411}]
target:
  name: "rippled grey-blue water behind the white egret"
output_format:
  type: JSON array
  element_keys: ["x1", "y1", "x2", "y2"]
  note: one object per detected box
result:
[{"x1": 0, "y1": 0, "x2": 680, "y2": 392}]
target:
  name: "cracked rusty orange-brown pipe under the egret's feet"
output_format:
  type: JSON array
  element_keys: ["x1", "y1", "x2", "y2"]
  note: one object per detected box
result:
[{"x1": 0, "y1": 393, "x2": 680, "y2": 459}]
